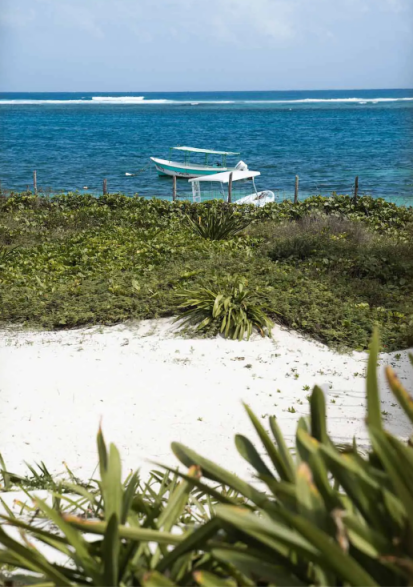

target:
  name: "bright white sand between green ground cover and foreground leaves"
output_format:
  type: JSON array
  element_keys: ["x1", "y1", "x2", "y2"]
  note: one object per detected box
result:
[{"x1": 0, "y1": 320, "x2": 410, "y2": 478}]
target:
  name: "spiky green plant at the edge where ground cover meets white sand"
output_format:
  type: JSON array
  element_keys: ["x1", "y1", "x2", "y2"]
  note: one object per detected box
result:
[{"x1": 177, "y1": 280, "x2": 273, "y2": 340}]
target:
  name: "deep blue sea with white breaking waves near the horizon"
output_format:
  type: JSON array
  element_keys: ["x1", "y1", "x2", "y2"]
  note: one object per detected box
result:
[{"x1": 0, "y1": 90, "x2": 413, "y2": 204}]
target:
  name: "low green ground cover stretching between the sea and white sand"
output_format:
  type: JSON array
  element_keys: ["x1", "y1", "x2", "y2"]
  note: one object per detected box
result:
[{"x1": 0, "y1": 193, "x2": 413, "y2": 350}]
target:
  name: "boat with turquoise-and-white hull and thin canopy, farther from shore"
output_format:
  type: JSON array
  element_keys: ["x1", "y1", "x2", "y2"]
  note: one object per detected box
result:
[{"x1": 151, "y1": 147, "x2": 248, "y2": 179}]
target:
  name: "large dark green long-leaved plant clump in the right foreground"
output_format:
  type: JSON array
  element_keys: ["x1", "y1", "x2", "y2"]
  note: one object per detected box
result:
[{"x1": 172, "y1": 335, "x2": 413, "y2": 586}]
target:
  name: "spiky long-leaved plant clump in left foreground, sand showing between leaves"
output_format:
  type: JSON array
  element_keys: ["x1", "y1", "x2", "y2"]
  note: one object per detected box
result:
[{"x1": 0, "y1": 431, "x2": 232, "y2": 586}]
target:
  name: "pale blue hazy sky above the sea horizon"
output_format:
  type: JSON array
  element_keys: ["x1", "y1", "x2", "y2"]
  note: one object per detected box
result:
[{"x1": 0, "y1": 0, "x2": 413, "y2": 92}]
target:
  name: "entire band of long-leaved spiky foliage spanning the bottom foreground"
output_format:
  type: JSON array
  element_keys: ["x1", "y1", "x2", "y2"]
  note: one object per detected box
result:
[{"x1": 0, "y1": 334, "x2": 413, "y2": 587}]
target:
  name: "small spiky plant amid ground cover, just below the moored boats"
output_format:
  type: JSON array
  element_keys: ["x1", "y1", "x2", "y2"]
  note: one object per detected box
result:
[{"x1": 186, "y1": 207, "x2": 252, "y2": 241}]
